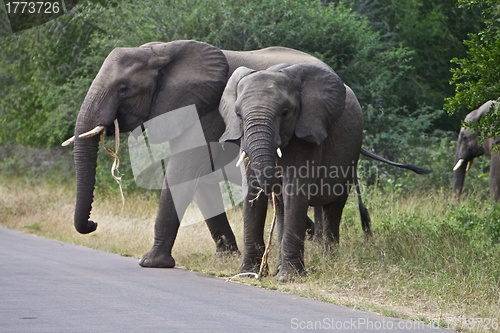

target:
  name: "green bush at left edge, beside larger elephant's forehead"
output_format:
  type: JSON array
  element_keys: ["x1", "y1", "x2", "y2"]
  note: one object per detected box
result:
[{"x1": 0, "y1": 2, "x2": 105, "y2": 146}]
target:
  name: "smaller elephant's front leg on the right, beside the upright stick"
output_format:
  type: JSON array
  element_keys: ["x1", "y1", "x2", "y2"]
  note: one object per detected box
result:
[{"x1": 277, "y1": 196, "x2": 309, "y2": 282}]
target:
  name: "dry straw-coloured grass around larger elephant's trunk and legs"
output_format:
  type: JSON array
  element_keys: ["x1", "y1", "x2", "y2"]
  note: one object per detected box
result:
[{"x1": 0, "y1": 176, "x2": 242, "y2": 265}]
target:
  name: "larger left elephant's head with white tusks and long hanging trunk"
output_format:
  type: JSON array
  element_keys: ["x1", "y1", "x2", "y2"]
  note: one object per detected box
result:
[{"x1": 65, "y1": 41, "x2": 228, "y2": 234}]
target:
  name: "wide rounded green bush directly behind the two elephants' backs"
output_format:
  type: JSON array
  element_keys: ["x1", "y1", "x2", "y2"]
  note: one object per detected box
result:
[{"x1": 82, "y1": 0, "x2": 426, "y2": 165}]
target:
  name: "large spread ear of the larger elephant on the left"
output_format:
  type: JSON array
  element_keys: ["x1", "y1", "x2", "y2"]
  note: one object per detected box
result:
[{"x1": 141, "y1": 40, "x2": 229, "y2": 119}]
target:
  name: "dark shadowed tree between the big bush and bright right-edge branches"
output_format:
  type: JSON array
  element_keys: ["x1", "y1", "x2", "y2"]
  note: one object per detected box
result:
[{"x1": 346, "y1": 0, "x2": 482, "y2": 130}]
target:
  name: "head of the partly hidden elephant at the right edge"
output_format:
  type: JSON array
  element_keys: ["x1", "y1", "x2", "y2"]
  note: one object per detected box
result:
[{"x1": 453, "y1": 101, "x2": 493, "y2": 195}]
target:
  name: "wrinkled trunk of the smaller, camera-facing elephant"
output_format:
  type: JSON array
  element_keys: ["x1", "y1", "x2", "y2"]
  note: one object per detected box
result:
[{"x1": 244, "y1": 120, "x2": 281, "y2": 194}]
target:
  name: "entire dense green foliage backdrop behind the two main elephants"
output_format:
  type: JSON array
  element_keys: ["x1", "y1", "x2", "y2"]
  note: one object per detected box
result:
[{"x1": 0, "y1": 0, "x2": 494, "y2": 192}]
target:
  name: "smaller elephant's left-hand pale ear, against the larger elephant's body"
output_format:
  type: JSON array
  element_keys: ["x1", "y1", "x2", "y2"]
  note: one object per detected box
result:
[{"x1": 219, "y1": 66, "x2": 255, "y2": 143}]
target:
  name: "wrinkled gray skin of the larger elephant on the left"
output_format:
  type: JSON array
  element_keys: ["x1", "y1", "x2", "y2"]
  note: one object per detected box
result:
[{"x1": 67, "y1": 41, "x2": 328, "y2": 267}]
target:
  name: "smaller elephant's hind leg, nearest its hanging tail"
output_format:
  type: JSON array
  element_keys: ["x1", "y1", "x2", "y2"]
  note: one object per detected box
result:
[{"x1": 323, "y1": 195, "x2": 347, "y2": 252}]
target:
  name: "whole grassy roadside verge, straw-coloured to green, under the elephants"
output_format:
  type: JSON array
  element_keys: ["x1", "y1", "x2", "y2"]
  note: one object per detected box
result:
[{"x1": 0, "y1": 170, "x2": 500, "y2": 332}]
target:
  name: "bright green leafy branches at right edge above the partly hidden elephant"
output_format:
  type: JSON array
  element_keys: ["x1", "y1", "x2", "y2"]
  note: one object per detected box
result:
[{"x1": 445, "y1": 0, "x2": 500, "y2": 137}]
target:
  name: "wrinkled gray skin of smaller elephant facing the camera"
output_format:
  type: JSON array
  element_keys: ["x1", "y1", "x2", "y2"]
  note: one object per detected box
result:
[{"x1": 219, "y1": 64, "x2": 363, "y2": 282}]
